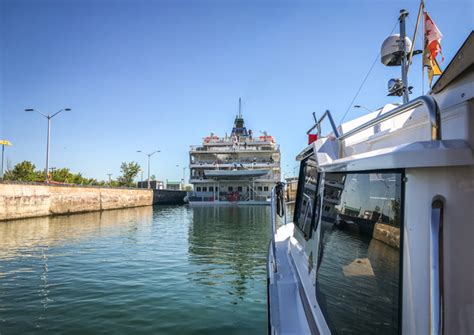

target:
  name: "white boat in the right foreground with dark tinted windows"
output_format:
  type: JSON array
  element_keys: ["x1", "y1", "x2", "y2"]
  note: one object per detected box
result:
[{"x1": 267, "y1": 9, "x2": 474, "y2": 334}]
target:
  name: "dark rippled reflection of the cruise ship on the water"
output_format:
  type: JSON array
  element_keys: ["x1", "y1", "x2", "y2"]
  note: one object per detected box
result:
[{"x1": 189, "y1": 207, "x2": 270, "y2": 303}]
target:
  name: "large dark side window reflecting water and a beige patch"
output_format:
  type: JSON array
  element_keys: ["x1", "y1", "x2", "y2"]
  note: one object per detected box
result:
[{"x1": 316, "y1": 172, "x2": 402, "y2": 334}]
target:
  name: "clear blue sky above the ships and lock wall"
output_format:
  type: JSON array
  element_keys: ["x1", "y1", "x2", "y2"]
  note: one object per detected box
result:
[{"x1": 0, "y1": 0, "x2": 474, "y2": 180}]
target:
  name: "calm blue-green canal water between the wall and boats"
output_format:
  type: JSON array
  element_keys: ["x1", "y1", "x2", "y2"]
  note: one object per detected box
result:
[{"x1": 0, "y1": 207, "x2": 270, "y2": 335}]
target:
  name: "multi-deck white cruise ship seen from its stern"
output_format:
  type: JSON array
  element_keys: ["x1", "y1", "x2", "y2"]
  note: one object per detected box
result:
[{"x1": 188, "y1": 99, "x2": 281, "y2": 205}]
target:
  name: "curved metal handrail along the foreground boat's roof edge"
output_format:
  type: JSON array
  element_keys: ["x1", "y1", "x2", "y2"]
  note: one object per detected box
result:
[{"x1": 339, "y1": 95, "x2": 441, "y2": 141}]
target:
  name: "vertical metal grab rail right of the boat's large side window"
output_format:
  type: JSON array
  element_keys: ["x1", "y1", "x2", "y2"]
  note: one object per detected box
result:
[{"x1": 430, "y1": 197, "x2": 444, "y2": 335}]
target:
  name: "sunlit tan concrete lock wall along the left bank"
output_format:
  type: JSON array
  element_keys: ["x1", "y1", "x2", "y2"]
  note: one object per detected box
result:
[{"x1": 0, "y1": 184, "x2": 153, "y2": 220}]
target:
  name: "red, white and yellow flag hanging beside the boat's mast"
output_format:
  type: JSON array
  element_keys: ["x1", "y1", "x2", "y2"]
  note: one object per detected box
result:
[{"x1": 423, "y1": 12, "x2": 444, "y2": 87}]
